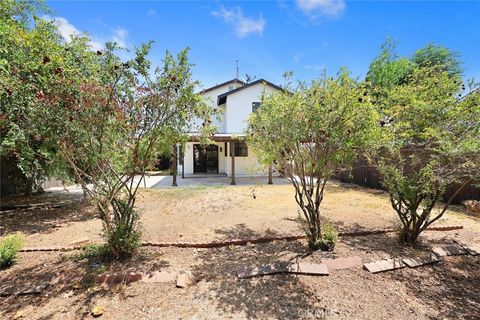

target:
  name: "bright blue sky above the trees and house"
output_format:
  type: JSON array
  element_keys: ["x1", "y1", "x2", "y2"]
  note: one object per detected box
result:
[{"x1": 47, "y1": 0, "x2": 480, "y2": 87}]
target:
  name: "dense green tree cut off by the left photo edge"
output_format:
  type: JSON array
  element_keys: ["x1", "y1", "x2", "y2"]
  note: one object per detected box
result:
[{"x1": 0, "y1": 1, "x2": 68, "y2": 193}]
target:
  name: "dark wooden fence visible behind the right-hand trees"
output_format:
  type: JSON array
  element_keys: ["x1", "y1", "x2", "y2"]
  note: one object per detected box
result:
[{"x1": 335, "y1": 158, "x2": 480, "y2": 204}]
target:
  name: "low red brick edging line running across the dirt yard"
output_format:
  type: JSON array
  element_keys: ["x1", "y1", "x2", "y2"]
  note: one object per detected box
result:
[{"x1": 19, "y1": 226, "x2": 463, "y2": 252}]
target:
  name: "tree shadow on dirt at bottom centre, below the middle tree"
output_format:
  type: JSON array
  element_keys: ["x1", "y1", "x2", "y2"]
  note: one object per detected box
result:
[{"x1": 192, "y1": 225, "x2": 336, "y2": 319}]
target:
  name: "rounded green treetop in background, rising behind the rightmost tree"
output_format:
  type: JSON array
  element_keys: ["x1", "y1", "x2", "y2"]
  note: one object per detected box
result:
[{"x1": 412, "y1": 44, "x2": 463, "y2": 79}]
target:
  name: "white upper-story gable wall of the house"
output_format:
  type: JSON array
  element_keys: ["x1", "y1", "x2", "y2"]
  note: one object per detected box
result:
[{"x1": 225, "y1": 83, "x2": 278, "y2": 133}]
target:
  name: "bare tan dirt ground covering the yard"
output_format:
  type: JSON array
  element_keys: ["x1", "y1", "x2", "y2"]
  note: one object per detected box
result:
[{"x1": 0, "y1": 184, "x2": 480, "y2": 319}]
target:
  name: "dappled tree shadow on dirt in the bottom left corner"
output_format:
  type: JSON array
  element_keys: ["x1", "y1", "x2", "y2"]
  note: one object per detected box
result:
[{"x1": 0, "y1": 250, "x2": 169, "y2": 319}]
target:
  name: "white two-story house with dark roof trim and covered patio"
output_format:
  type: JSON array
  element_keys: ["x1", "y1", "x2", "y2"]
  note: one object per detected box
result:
[{"x1": 178, "y1": 79, "x2": 282, "y2": 183}]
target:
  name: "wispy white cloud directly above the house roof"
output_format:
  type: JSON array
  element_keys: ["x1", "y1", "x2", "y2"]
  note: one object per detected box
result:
[{"x1": 212, "y1": 6, "x2": 266, "y2": 38}]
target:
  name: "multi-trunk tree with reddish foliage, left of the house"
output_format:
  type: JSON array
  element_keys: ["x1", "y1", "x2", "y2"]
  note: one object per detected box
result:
[{"x1": 42, "y1": 41, "x2": 209, "y2": 258}]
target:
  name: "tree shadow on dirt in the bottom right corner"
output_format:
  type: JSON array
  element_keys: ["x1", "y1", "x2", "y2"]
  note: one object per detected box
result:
[{"x1": 342, "y1": 234, "x2": 480, "y2": 320}]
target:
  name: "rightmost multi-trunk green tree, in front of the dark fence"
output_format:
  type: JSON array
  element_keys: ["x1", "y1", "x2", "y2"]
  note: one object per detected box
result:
[{"x1": 377, "y1": 67, "x2": 480, "y2": 244}]
